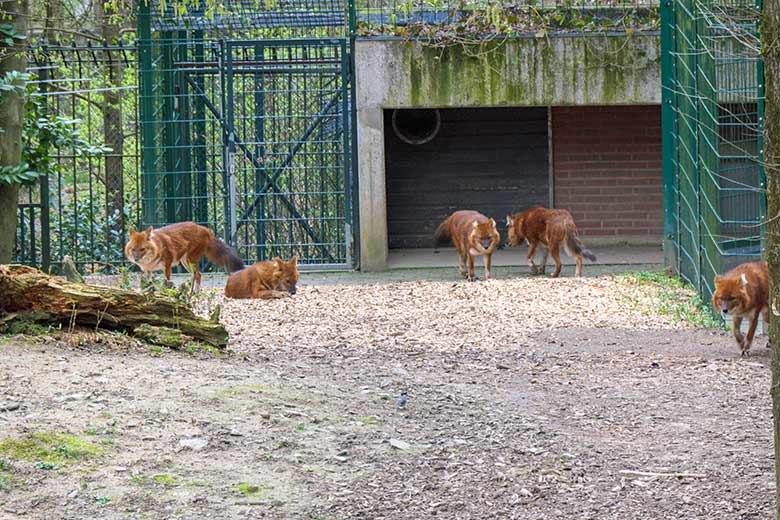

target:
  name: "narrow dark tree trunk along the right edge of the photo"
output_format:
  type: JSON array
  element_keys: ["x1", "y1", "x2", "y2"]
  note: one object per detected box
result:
[{"x1": 761, "y1": 0, "x2": 780, "y2": 519}]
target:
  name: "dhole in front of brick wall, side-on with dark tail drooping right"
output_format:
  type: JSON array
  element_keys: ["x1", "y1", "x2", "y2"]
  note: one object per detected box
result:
[{"x1": 506, "y1": 208, "x2": 596, "y2": 278}]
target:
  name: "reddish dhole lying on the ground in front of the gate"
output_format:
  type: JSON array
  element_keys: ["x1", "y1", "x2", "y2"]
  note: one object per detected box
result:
[{"x1": 225, "y1": 256, "x2": 298, "y2": 298}]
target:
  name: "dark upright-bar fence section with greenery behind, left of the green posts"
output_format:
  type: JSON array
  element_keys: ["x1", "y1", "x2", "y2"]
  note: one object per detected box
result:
[{"x1": 15, "y1": 43, "x2": 140, "y2": 272}]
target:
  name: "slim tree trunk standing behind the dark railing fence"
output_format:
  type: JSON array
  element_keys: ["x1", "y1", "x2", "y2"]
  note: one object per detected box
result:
[{"x1": 94, "y1": 1, "x2": 125, "y2": 254}]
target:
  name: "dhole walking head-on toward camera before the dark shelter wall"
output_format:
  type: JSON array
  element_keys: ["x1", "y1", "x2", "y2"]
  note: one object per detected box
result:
[{"x1": 434, "y1": 210, "x2": 501, "y2": 280}]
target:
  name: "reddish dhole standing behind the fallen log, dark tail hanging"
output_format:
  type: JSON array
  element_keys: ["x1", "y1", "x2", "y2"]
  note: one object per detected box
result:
[{"x1": 125, "y1": 222, "x2": 244, "y2": 291}]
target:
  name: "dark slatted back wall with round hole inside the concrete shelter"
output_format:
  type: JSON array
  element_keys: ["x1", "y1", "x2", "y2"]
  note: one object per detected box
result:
[{"x1": 385, "y1": 107, "x2": 550, "y2": 249}]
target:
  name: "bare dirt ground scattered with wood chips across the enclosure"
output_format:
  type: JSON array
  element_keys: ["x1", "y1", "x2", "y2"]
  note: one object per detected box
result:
[{"x1": 0, "y1": 271, "x2": 774, "y2": 520}]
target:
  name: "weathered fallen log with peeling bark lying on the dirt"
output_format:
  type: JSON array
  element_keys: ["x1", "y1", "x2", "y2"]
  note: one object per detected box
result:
[{"x1": 0, "y1": 265, "x2": 228, "y2": 348}]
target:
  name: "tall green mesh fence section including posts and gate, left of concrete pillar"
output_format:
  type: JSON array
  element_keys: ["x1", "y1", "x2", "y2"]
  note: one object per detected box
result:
[{"x1": 139, "y1": 0, "x2": 356, "y2": 267}]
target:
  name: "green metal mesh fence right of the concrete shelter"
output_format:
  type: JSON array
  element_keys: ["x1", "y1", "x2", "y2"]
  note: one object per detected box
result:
[{"x1": 661, "y1": 0, "x2": 766, "y2": 299}]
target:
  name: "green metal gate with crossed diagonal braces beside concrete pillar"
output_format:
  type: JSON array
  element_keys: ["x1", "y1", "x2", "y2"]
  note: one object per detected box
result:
[{"x1": 225, "y1": 39, "x2": 351, "y2": 265}]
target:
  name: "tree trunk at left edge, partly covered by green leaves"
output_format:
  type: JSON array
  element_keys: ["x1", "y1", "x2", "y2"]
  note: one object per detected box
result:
[{"x1": 0, "y1": 0, "x2": 28, "y2": 263}]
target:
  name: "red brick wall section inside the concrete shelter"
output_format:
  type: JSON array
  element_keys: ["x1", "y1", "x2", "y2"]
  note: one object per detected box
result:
[{"x1": 552, "y1": 105, "x2": 663, "y2": 242}]
